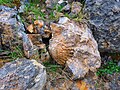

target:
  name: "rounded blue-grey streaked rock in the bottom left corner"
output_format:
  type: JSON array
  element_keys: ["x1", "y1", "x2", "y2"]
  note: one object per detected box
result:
[{"x1": 0, "y1": 59, "x2": 47, "y2": 90}]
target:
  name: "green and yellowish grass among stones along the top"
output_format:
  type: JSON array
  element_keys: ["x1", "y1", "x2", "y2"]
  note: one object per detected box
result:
[{"x1": 0, "y1": 0, "x2": 85, "y2": 22}]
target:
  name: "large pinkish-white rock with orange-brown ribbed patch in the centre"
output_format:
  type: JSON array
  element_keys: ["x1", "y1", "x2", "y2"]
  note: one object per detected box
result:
[{"x1": 49, "y1": 17, "x2": 101, "y2": 79}]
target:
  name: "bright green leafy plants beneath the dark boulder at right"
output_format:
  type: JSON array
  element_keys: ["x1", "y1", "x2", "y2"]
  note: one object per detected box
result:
[{"x1": 97, "y1": 61, "x2": 120, "y2": 76}]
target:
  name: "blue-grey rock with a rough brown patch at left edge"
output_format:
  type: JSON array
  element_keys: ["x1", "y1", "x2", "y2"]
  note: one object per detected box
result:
[{"x1": 0, "y1": 5, "x2": 25, "y2": 50}]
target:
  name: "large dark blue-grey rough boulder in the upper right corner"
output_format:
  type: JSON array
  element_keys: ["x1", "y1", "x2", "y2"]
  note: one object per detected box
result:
[{"x1": 85, "y1": 0, "x2": 120, "y2": 52}]
